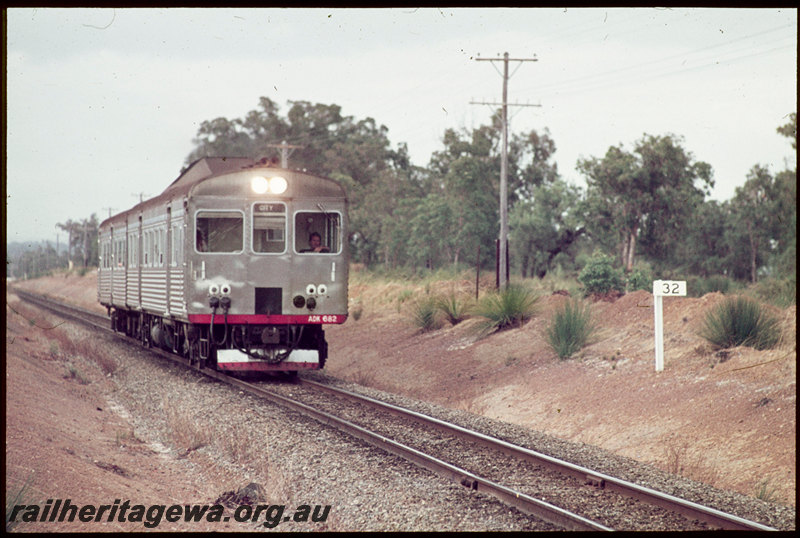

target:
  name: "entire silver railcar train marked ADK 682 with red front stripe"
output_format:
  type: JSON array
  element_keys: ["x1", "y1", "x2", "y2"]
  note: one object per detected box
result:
[{"x1": 98, "y1": 158, "x2": 348, "y2": 371}]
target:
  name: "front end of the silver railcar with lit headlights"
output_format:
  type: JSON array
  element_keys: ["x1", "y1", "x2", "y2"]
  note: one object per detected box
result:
[{"x1": 186, "y1": 168, "x2": 348, "y2": 371}]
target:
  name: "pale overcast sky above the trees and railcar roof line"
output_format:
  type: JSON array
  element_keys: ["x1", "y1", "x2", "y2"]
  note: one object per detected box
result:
[{"x1": 5, "y1": 8, "x2": 797, "y2": 244}]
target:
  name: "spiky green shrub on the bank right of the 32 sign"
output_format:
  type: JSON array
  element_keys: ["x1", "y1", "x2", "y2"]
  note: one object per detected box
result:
[{"x1": 700, "y1": 296, "x2": 781, "y2": 349}]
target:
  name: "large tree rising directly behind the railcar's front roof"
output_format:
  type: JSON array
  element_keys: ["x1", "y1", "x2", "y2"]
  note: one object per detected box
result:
[{"x1": 186, "y1": 97, "x2": 418, "y2": 263}]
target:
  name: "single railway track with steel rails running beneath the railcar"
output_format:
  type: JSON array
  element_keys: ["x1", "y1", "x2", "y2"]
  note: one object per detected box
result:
[{"x1": 7, "y1": 286, "x2": 776, "y2": 531}]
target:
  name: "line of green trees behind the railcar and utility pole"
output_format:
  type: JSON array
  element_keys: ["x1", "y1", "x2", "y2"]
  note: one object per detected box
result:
[{"x1": 10, "y1": 97, "x2": 797, "y2": 294}]
